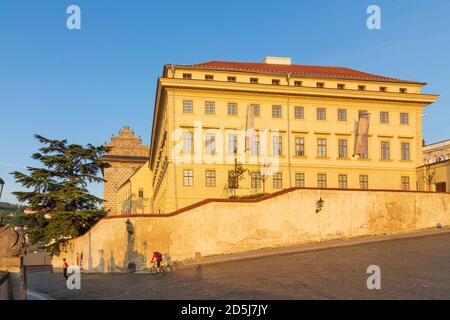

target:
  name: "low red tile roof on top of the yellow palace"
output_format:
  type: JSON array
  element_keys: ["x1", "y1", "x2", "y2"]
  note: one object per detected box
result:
[{"x1": 181, "y1": 61, "x2": 425, "y2": 84}]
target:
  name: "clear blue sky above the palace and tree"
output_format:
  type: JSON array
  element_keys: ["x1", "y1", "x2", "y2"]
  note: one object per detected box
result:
[{"x1": 0, "y1": 0, "x2": 450, "y2": 202}]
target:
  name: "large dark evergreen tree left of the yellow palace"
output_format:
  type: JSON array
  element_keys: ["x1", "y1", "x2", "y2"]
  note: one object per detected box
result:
[{"x1": 11, "y1": 135, "x2": 108, "y2": 254}]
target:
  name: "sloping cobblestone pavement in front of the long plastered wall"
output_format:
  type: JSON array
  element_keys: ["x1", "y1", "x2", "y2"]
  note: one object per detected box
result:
[{"x1": 28, "y1": 234, "x2": 450, "y2": 299}]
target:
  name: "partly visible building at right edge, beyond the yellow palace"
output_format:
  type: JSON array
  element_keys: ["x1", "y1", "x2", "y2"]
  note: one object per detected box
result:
[{"x1": 418, "y1": 139, "x2": 450, "y2": 192}]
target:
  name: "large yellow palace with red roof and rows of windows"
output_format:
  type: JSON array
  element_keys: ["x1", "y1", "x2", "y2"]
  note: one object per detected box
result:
[{"x1": 114, "y1": 57, "x2": 437, "y2": 213}]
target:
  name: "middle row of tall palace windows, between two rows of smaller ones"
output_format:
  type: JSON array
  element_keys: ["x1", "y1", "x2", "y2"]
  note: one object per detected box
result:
[{"x1": 183, "y1": 131, "x2": 411, "y2": 161}]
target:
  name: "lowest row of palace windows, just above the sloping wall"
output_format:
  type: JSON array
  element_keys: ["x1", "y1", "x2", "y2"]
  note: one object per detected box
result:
[{"x1": 183, "y1": 169, "x2": 410, "y2": 191}]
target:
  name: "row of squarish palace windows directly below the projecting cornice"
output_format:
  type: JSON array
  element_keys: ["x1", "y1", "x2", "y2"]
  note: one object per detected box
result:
[{"x1": 183, "y1": 100, "x2": 409, "y2": 125}]
